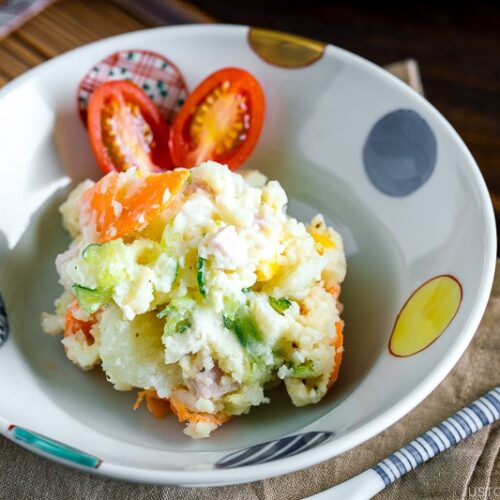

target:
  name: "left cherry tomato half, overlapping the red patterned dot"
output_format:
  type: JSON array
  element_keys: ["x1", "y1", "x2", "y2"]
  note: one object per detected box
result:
[{"x1": 87, "y1": 80, "x2": 172, "y2": 173}]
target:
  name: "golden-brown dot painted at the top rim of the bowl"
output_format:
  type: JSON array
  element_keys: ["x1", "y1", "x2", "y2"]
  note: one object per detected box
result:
[{"x1": 248, "y1": 28, "x2": 326, "y2": 68}]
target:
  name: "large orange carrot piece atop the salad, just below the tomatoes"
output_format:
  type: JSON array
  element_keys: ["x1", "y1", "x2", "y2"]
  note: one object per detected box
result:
[{"x1": 79, "y1": 169, "x2": 189, "y2": 243}]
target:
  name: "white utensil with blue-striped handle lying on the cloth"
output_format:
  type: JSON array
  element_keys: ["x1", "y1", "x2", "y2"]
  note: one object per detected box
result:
[{"x1": 308, "y1": 386, "x2": 500, "y2": 500}]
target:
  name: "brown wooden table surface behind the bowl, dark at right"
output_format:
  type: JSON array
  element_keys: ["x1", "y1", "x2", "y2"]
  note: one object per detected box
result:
[{"x1": 0, "y1": 0, "x2": 500, "y2": 248}]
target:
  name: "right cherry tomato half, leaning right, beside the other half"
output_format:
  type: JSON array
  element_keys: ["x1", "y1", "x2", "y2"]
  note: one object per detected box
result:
[{"x1": 170, "y1": 68, "x2": 266, "y2": 170}]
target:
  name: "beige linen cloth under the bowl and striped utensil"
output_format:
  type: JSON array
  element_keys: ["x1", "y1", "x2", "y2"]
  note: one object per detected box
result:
[{"x1": 0, "y1": 262, "x2": 500, "y2": 500}]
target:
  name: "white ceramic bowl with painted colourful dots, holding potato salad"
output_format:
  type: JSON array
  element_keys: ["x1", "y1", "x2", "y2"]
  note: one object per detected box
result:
[{"x1": 0, "y1": 25, "x2": 496, "y2": 485}]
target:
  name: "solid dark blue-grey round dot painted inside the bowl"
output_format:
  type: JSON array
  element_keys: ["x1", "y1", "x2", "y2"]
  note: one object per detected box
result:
[{"x1": 363, "y1": 109, "x2": 437, "y2": 196}]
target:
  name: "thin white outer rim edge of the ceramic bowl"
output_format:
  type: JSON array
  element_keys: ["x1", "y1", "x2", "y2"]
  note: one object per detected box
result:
[{"x1": 0, "y1": 24, "x2": 496, "y2": 487}]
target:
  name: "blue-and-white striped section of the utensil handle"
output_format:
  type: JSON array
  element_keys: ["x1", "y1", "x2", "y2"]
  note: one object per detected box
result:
[{"x1": 372, "y1": 386, "x2": 500, "y2": 486}]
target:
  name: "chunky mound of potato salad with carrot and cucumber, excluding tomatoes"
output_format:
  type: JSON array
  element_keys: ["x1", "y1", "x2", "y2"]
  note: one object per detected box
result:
[{"x1": 42, "y1": 162, "x2": 346, "y2": 438}]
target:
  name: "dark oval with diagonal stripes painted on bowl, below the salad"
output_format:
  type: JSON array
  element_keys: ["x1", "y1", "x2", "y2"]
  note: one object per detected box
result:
[{"x1": 215, "y1": 432, "x2": 333, "y2": 469}]
